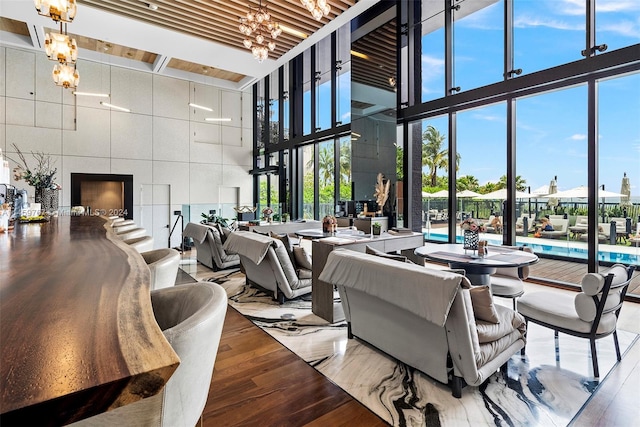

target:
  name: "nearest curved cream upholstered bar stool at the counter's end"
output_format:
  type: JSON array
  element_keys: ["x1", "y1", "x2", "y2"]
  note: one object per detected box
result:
[{"x1": 70, "y1": 282, "x2": 227, "y2": 427}]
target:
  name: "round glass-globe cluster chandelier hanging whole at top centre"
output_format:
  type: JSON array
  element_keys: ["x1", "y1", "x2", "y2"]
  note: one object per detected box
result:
[{"x1": 238, "y1": 0, "x2": 282, "y2": 62}]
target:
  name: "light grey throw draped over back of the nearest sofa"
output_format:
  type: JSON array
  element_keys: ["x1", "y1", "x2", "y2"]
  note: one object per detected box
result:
[{"x1": 320, "y1": 249, "x2": 465, "y2": 326}]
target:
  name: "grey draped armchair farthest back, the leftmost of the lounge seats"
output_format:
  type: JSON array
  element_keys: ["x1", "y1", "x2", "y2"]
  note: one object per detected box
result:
[{"x1": 182, "y1": 222, "x2": 240, "y2": 270}]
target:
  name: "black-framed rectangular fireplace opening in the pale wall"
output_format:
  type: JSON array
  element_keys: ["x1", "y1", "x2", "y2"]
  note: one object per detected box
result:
[{"x1": 71, "y1": 173, "x2": 133, "y2": 219}]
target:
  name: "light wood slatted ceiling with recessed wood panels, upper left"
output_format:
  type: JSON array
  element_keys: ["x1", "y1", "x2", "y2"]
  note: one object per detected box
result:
[{"x1": 78, "y1": 0, "x2": 357, "y2": 82}]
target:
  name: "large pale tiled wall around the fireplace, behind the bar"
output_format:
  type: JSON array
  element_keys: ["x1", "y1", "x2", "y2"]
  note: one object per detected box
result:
[{"x1": 0, "y1": 47, "x2": 253, "y2": 247}]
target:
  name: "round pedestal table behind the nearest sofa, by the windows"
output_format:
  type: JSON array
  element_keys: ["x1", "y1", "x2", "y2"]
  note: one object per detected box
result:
[{"x1": 414, "y1": 243, "x2": 538, "y2": 285}]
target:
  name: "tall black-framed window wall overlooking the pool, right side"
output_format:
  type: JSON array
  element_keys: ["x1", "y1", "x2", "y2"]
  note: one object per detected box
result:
[{"x1": 398, "y1": 0, "x2": 640, "y2": 278}]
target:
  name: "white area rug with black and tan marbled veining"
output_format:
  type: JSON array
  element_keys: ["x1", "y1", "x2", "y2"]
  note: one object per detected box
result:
[{"x1": 199, "y1": 270, "x2": 637, "y2": 426}]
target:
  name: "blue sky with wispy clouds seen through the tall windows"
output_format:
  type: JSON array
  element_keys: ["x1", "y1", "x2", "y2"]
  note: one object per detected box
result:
[{"x1": 422, "y1": 0, "x2": 640, "y2": 196}]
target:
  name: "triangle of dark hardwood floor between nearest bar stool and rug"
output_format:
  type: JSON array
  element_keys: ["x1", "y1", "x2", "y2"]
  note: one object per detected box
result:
[{"x1": 202, "y1": 307, "x2": 387, "y2": 427}]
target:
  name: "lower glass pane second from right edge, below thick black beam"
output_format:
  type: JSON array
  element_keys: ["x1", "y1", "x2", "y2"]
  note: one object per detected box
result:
[{"x1": 516, "y1": 85, "x2": 588, "y2": 280}]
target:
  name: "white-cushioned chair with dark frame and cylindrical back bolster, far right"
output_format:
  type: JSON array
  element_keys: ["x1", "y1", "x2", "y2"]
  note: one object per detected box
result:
[{"x1": 518, "y1": 264, "x2": 635, "y2": 378}]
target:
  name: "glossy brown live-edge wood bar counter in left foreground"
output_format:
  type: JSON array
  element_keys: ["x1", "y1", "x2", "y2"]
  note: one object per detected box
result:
[{"x1": 0, "y1": 216, "x2": 179, "y2": 427}]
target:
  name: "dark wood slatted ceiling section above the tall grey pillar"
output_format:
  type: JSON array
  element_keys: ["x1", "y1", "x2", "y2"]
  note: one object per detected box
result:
[{"x1": 351, "y1": 19, "x2": 397, "y2": 91}]
